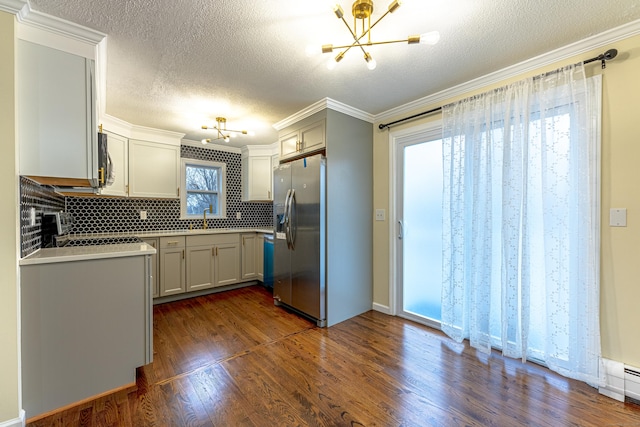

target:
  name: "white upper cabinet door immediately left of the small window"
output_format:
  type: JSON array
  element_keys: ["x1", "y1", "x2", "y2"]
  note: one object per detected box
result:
[{"x1": 129, "y1": 139, "x2": 180, "y2": 198}]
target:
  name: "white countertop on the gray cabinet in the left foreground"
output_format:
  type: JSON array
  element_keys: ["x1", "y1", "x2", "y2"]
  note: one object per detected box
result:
[{"x1": 20, "y1": 243, "x2": 156, "y2": 265}]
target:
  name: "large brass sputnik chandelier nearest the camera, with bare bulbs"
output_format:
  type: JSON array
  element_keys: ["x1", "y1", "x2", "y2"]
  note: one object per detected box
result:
[{"x1": 322, "y1": 0, "x2": 440, "y2": 70}]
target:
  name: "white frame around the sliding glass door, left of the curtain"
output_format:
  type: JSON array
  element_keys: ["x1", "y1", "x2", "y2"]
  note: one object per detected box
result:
[{"x1": 389, "y1": 119, "x2": 442, "y2": 316}]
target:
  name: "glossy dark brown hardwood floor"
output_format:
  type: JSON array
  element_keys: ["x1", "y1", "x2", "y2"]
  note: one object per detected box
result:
[{"x1": 29, "y1": 286, "x2": 640, "y2": 427}]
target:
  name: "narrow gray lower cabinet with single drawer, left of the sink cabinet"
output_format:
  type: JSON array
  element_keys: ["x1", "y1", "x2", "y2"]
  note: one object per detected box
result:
[{"x1": 158, "y1": 236, "x2": 187, "y2": 297}]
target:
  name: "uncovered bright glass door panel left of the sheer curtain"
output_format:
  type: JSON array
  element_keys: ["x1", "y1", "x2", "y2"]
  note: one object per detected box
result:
[{"x1": 395, "y1": 128, "x2": 442, "y2": 326}]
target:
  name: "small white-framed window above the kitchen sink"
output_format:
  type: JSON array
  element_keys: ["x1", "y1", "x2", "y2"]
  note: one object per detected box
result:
[{"x1": 180, "y1": 159, "x2": 227, "y2": 219}]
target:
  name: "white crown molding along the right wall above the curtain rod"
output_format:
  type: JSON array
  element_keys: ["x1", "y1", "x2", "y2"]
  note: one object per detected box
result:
[{"x1": 374, "y1": 20, "x2": 640, "y2": 122}]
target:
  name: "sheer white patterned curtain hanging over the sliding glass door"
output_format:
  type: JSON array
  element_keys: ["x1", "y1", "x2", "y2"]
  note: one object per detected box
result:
[{"x1": 442, "y1": 64, "x2": 601, "y2": 386}]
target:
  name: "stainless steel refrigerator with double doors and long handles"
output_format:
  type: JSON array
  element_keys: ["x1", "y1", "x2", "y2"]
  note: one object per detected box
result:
[{"x1": 273, "y1": 154, "x2": 327, "y2": 326}]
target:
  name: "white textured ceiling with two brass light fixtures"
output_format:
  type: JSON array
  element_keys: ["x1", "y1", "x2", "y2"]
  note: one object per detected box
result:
[{"x1": 30, "y1": 0, "x2": 640, "y2": 146}]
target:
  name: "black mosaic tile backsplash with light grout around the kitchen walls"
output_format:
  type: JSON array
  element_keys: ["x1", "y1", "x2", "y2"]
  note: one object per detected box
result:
[{"x1": 20, "y1": 145, "x2": 273, "y2": 257}]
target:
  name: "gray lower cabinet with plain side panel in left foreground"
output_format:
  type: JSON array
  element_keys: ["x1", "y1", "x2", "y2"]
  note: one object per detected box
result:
[{"x1": 20, "y1": 255, "x2": 153, "y2": 418}]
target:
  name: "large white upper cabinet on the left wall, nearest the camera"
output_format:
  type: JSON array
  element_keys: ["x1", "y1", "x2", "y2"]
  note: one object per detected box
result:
[{"x1": 16, "y1": 39, "x2": 98, "y2": 187}]
